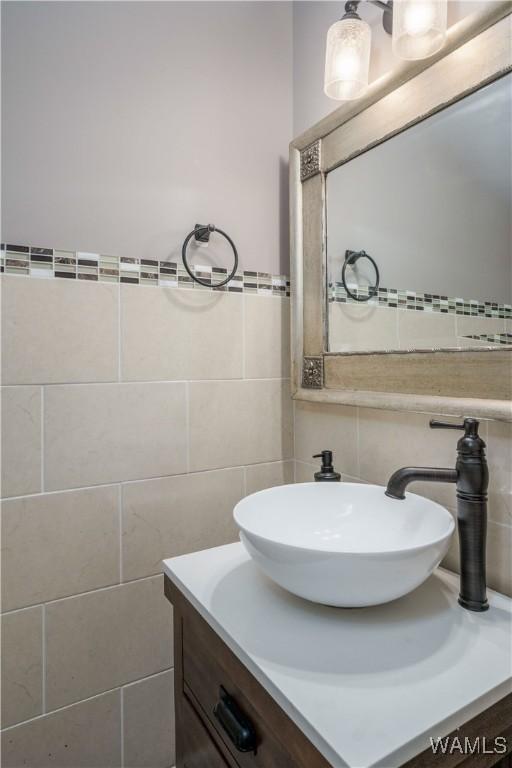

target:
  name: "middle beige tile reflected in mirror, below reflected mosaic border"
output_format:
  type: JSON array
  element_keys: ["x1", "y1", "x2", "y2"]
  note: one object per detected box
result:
[{"x1": 398, "y1": 309, "x2": 456, "y2": 349}]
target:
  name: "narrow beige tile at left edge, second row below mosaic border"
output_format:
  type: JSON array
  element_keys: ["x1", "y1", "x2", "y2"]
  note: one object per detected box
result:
[{"x1": 0, "y1": 387, "x2": 41, "y2": 496}]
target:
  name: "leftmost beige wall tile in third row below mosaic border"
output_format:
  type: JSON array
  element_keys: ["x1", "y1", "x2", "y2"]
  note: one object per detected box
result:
[{"x1": 2, "y1": 487, "x2": 119, "y2": 610}]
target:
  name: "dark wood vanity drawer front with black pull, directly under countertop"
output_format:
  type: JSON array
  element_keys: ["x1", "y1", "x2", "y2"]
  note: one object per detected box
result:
[{"x1": 181, "y1": 596, "x2": 329, "y2": 768}]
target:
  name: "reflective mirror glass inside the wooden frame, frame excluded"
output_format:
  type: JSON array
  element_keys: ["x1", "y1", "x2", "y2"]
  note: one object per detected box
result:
[{"x1": 327, "y1": 74, "x2": 512, "y2": 352}]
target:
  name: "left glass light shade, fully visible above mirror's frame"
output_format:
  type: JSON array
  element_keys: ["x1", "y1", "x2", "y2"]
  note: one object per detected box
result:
[{"x1": 324, "y1": 19, "x2": 372, "y2": 101}]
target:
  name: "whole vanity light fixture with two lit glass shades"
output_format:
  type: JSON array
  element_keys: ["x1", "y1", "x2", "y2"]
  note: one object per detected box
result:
[{"x1": 324, "y1": 0, "x2": 448, "y2": 101}]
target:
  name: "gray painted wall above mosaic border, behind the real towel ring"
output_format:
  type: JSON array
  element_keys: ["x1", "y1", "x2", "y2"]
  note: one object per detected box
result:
[{"x1": 2, "y1": 2, "x2": 292, "y2": 272}]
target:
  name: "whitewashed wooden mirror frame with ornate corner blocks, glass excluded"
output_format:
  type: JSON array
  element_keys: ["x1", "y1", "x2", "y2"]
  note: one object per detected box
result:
[{"x1": 290, "y1": 0, "x2": 512, "y2": 421}]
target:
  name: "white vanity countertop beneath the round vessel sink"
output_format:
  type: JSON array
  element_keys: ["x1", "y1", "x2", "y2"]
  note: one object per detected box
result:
[{"x1": 164, "y1": 544, "x2": 512, "y2": 768}]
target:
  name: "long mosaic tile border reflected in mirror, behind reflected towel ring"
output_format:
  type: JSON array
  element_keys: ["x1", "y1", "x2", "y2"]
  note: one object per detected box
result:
[{"x1": 328, "y1": 283, "x2": 512, "y2": 318}]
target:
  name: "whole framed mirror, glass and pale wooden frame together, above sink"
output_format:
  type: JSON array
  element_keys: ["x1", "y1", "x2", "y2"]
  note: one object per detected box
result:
[{"x1": 291, "y1": 2, "x2": 512, "y2": 420}]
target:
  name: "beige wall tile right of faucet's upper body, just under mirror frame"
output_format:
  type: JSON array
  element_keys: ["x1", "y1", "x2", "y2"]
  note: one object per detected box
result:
[{"x1": 485, "y1": 421, "x2": 512, "y2": 525}]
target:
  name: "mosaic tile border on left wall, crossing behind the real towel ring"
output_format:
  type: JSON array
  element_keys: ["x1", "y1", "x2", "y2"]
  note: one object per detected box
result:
[{"x1": 0, "y1": 244, "x2": 290, "y2": 296}]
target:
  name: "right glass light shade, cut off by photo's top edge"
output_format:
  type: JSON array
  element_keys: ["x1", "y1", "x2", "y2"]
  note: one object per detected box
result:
[{"x1": 393, "y1": 0, "x2": 448, "y2": 59}]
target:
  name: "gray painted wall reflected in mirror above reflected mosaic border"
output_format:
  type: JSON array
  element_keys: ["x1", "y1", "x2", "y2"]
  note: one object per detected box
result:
[{"x1": 327, "y1": 75, "x2": 512, "y2": 304}]
